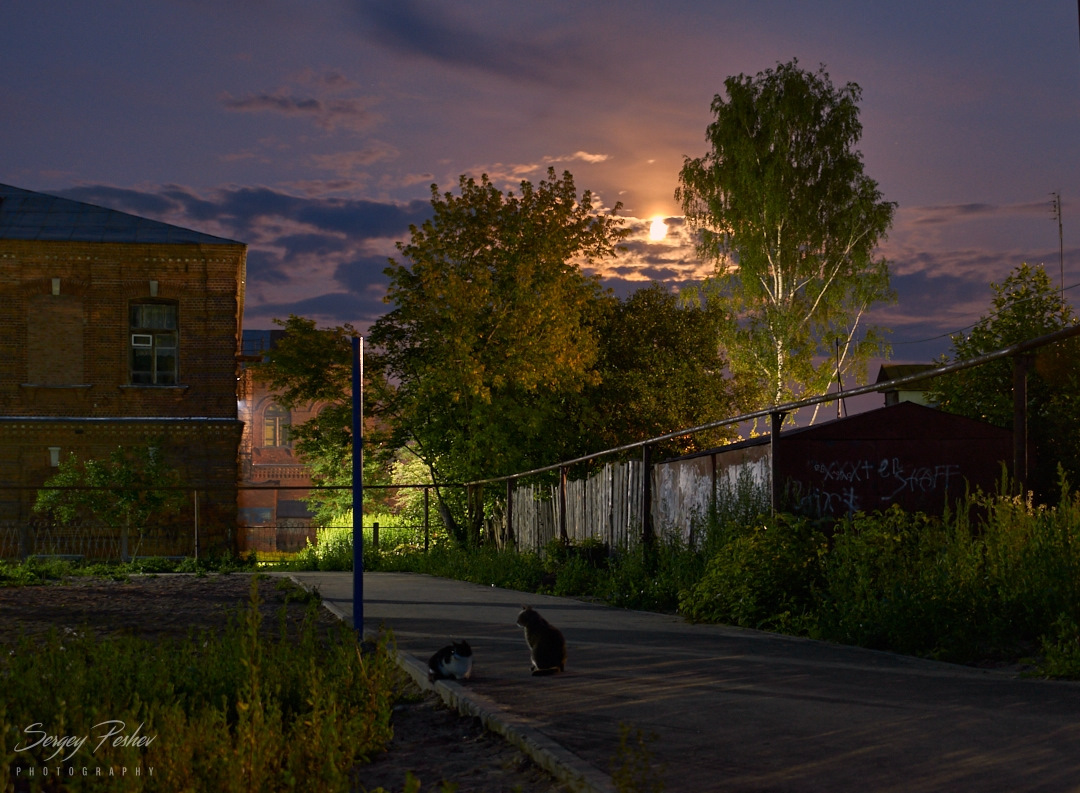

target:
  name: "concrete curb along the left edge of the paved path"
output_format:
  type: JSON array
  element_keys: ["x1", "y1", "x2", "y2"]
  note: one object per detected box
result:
[{"x1": 288, "y1": 575, "x2": 616, "y2": 793}]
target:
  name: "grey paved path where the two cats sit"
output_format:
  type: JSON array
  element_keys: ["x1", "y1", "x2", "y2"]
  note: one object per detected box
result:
[{"x1": 285, "y1": 573, "x2": 1080, "y2": 793}]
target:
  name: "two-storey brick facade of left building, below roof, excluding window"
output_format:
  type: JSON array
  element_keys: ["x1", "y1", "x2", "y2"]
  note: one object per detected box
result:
[{"x1": 0, "y1": 240, "x2": 246, "y2": 548}]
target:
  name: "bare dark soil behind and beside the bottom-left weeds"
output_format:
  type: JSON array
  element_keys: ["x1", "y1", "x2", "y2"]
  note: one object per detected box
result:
[{"x1": 0, "y1": 574, "x2": 567, "y2": 793}]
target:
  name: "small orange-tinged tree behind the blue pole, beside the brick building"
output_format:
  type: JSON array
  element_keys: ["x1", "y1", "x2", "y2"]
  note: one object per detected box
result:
[{"x1": 254, "y1": 314, "x2": 388, "y2": 526}]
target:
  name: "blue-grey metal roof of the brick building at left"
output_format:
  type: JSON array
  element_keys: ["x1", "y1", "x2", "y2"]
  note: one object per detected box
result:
[{"x1": 0, "y1": 185, "x2": 242, "y2": 245}]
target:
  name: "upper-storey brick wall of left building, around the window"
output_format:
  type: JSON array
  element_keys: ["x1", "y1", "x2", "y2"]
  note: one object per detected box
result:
[{"x1": 0, "y1": 240, "x2": 245, "y2": 417}]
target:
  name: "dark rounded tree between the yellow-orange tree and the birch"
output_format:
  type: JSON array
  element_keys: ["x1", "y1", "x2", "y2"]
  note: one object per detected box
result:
[{"x1": 590, "y1": 283, "x2": 740, "y2": 454}]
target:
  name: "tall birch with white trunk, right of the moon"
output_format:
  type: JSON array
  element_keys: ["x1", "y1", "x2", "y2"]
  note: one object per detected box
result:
[{"x1": 675, "y1": 61, "x2": 895, "y2": 417}]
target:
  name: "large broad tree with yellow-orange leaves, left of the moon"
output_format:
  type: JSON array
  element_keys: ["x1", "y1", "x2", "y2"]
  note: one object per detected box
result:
[{"x1": 370, "y1": 169, "x2": 626, "y2": 540}]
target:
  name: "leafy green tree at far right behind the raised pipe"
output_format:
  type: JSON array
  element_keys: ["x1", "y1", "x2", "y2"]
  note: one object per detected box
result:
[{"x1": 927, "y1": 263, "x2": 1080, "y2": 498}]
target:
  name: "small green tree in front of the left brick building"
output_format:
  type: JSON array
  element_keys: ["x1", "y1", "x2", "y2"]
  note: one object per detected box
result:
[{"x1": 33, "y1": 442, "x2": 187, "y2": 560}]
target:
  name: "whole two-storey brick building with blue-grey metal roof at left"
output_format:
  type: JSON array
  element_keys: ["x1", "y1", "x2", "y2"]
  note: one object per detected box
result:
[{"x1": 0, "y1": 185, "x2": 246, "y2": 556}]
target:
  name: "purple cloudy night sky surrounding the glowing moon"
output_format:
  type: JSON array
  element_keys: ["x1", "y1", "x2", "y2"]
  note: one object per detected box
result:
[{"x1": 0, "y1": 0, "x2": 1080, "y2": 362}]
